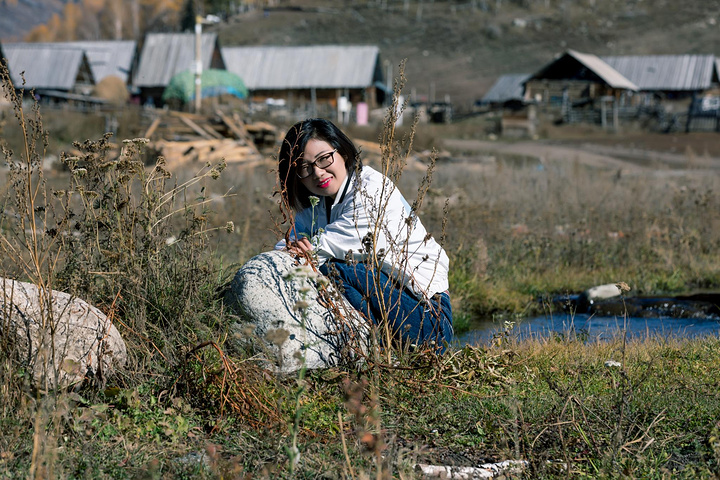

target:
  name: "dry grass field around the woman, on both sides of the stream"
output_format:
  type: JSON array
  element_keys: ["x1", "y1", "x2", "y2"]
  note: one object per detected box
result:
[{"x1": 0, "y1": 84, "x2": 720, "y2": 478}]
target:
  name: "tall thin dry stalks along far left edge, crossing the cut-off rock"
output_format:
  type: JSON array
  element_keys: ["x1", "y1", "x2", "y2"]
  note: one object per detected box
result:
[{"x1": 0, "y1": 58, "x2": 67, "y2": 478}]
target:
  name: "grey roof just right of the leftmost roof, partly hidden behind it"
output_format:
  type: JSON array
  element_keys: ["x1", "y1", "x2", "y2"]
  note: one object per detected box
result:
[{"x1": 59, "y1": 40, "x2": 137, "y2": 83}]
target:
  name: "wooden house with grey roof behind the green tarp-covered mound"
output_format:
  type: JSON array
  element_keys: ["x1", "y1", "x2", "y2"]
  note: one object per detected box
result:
[{"x1": 132, "y1": 33, "x2": 225, "y2": 106}]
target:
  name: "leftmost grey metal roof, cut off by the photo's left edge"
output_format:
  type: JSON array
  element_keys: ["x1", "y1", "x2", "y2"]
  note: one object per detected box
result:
[{"x1": 3, "y1": 43, "x2": 88, "y2": 91}]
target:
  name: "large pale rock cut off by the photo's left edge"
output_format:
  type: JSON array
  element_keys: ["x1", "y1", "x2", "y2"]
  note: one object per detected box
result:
[{"x1": 0, "y1": 278, "x2": 127, "y2": 391}]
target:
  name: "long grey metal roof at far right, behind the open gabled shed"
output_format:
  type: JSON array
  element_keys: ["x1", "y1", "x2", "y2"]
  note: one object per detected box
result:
[{"x1": 603, "y1": 55, "x2": 717, "y2": 91}]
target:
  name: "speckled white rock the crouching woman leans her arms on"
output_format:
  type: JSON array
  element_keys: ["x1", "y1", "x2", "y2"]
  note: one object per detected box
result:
[{"x1": 225, "y1": 250, "x2": 369, "y2": 373}]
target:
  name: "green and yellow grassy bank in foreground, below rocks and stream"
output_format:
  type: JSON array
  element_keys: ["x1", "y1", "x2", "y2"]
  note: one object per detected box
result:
[{"x1": 0, "y1": 332, "x2": 720, "y2": 478}]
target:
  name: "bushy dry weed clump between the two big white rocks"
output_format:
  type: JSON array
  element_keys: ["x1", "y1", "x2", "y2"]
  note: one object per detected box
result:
[{"x1": 54, "y1": 135, "x2": 232, "y2": 372}]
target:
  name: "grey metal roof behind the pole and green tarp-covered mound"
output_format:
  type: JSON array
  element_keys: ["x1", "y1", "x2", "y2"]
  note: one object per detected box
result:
[{"x1": 133, "y1": 33, "x2": 217, "y2": 87}]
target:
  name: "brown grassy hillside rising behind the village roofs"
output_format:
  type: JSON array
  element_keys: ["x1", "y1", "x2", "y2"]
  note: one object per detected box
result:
[{"x1": 219, "y1": 0, "x2": 720, "y2": 105}]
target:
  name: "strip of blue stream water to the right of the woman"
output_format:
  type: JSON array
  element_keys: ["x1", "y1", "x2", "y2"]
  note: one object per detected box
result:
[{"x1": 457, "y1": 314, "x2": 720, "y2": 346}]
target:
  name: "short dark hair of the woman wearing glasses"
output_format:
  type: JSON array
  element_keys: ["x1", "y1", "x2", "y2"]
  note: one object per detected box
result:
[{"x1": 278, "y1": 118, "x2": 362, "y2": 211}]
